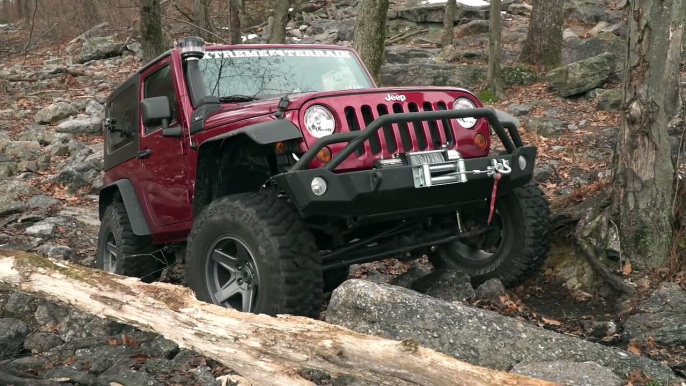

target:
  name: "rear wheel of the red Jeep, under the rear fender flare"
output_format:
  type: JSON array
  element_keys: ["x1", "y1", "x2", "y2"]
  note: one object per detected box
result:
[{"x1": 95, "y1": 201, "x2": 165, "y2": 283}]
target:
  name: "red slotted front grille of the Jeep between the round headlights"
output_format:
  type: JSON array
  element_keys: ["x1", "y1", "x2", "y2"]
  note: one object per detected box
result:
[{"x1": 341, "y1": 101, "x2": 460, "y2": 157}]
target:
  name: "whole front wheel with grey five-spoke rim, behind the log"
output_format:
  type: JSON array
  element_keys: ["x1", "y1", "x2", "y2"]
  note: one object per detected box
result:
[{"x1": 186, "y1": 193, "x2": 324, "y2": 318}]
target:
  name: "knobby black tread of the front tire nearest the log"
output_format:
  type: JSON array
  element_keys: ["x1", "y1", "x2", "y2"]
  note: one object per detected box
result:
[{"x1": 186, "y1": 191, "x2": 324, "y2": 318}]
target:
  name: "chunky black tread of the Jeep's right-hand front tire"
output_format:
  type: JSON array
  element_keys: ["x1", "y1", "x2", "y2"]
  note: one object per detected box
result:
[{"x1": 436, "y1": 181, "x2": 551, "y2": 288}]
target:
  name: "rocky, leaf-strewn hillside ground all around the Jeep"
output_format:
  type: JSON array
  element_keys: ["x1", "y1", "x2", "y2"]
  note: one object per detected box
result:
[{"x1": 0, "y1": 0, "x2": 686, "y2": 385}]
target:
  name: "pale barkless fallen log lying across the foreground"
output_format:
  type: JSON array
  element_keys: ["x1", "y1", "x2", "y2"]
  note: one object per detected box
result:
[{"x1": 0, "y1": 250, "x2": 555, "y2": 386}]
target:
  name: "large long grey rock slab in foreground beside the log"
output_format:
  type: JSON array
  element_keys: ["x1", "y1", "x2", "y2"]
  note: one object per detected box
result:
[{"x1": 326, "y1": 279, "x2": 675, "y2": 382}]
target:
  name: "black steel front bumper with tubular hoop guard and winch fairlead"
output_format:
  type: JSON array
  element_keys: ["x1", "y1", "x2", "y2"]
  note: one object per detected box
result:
[{"x1": 272, "y1": 108, "x2": 536, "y2": 217}]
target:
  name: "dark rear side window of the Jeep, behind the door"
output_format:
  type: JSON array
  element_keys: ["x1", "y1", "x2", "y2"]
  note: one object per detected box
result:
[{"x1": 107, "y1": 85, "x2": 138, "y2": 153}]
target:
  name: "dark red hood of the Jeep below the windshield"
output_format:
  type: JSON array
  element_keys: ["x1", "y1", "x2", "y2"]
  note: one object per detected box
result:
[{"x1": 200, "y1": 86, "x2": 477, "y2": 129}]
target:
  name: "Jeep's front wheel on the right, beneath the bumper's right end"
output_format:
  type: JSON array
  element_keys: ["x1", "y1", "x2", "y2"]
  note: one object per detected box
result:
[{"x1": 436, "y1": 181, "x2": 550, "y2": 288}]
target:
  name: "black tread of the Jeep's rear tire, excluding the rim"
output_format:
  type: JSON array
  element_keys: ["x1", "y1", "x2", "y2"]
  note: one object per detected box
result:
[{"x1": 103, "y1": 201, "x2": 164, "y2": 283}]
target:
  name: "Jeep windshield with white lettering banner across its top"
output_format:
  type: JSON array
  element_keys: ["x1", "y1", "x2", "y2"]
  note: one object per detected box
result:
[{"x1": 200, "y1": 49, "x2": 373, "y2": 102}]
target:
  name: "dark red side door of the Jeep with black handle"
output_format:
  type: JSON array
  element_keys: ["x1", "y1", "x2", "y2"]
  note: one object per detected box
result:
[{"x1": 137, "y1": 57, "x2": 192, "y2": 227}]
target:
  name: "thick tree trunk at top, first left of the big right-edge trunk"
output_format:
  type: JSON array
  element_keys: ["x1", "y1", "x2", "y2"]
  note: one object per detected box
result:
[{"x1": 524, "y1": 0, "x2": 565, "y2": 70}]
